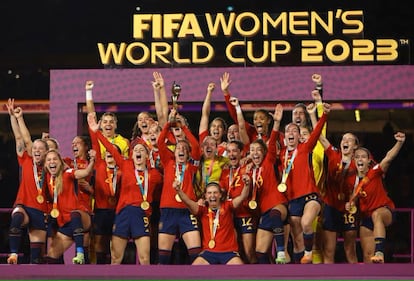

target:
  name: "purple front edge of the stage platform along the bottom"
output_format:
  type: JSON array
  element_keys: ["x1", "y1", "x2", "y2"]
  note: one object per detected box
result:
[{"x1": 0, "y1": 264, "x2": 414, "y2": 280}]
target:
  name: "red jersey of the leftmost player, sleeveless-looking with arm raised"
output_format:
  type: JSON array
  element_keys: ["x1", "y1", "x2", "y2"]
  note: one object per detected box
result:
[{"x1": 14, "y1": 151, "x2": 47, "y2": 213}]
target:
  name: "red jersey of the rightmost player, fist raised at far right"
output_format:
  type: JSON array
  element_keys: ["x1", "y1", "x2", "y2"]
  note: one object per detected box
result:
[{"x1": 348, "y1": 164, "x2": 395, "y2": 217}]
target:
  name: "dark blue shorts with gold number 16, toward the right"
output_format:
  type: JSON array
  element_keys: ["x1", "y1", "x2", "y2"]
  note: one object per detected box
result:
[{"x1": 322, "y1": 205, "x2": 358, "y2": 233}]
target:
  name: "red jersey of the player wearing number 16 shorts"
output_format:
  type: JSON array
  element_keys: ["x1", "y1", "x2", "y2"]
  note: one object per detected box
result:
[{"x1": 322, "y1": 145, "x2": 356, "y2": 209}]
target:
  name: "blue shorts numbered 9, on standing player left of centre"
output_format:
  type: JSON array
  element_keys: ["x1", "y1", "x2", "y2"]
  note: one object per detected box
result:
[{"x1": 112, "y1": 206, "x2": 149, "y2": 239}]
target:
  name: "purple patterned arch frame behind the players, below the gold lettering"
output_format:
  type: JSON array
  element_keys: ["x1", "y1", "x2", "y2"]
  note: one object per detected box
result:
[{"x1": 50, "y1": 65, "x2": 414, "y2": 155}]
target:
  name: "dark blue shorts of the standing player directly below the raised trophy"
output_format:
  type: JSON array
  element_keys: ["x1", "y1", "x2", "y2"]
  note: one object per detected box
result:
[{"x1": 158, "y1": 208, "x2": 198, "y2": 235}]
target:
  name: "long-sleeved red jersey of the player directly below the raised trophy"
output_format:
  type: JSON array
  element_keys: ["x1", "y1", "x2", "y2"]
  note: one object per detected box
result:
[{"x1": 158, "y1": 123, "x2": 200, "y2": 209}]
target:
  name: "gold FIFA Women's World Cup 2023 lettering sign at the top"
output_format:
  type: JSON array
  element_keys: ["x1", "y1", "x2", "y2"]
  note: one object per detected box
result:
[{"x1": 97, "y1": 9, "x2": 409, "y2": 66}]
